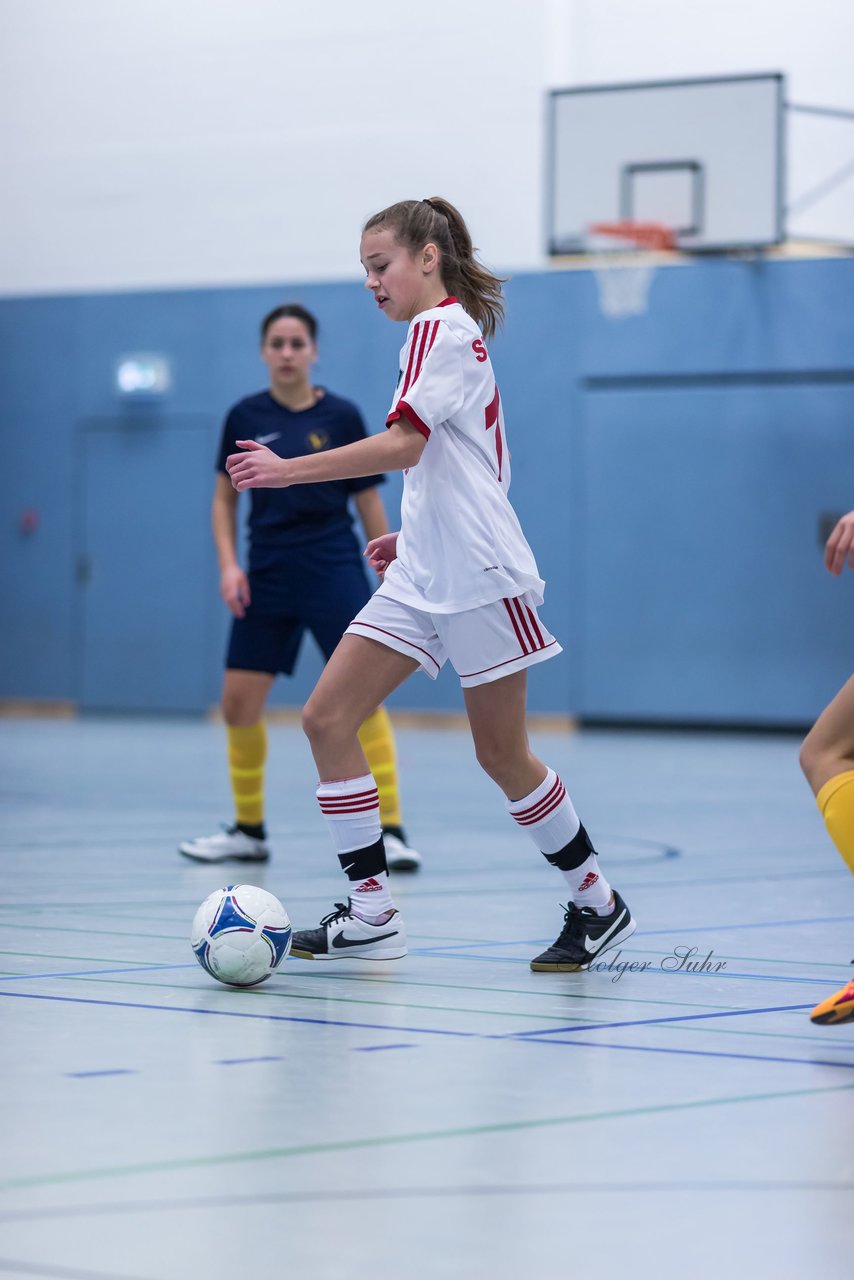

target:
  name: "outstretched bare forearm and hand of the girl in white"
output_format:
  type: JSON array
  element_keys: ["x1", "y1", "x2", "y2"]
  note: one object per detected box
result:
[{"x1": 225, "y1": 419, "x2": 426, "y2": 493}]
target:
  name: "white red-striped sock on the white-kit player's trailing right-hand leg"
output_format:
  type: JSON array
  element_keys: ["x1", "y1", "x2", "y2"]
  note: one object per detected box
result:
[{"x1": 507, "y1": 769, "x2": 611, "y2": 915}]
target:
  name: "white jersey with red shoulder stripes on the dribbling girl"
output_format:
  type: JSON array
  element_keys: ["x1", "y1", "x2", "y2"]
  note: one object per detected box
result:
[{"x1": 380, "y1": 298, "x2": 544, "y2": 613}]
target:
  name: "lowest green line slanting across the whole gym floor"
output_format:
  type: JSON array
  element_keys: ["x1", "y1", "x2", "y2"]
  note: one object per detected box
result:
[{"x1": 0, "y1": 1084, "x2": 854, "y2": 1192}]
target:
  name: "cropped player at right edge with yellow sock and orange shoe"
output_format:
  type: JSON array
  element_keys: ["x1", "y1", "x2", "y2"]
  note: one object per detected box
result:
[{"x1": 800, "y1": 511, "x2": 854, "y2": 1024}]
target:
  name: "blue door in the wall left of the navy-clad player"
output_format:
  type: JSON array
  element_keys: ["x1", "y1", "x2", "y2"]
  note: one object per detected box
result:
[{"x1": 77, "y1": 412, "x2": 222, "y2": 712}]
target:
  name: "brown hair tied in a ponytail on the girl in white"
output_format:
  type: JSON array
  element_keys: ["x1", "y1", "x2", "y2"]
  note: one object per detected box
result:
[{"x1": 364, "y1": 196, "x2": 504, "y2": 338}]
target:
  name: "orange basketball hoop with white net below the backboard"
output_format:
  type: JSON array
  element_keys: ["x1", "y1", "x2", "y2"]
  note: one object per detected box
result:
[{"x1": 586, "y1": 219, "x2": 676, "y2": 317}]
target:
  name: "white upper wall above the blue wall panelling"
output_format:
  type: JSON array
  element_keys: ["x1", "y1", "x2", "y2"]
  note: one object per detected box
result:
[{"x1": 0, "y1": 0, "x2": 854, "y2": 294}]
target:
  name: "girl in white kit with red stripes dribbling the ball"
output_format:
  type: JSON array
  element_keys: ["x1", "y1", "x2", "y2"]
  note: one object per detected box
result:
[{"x1": 227, "y1": 197, "x2": 635, "y2": 970}]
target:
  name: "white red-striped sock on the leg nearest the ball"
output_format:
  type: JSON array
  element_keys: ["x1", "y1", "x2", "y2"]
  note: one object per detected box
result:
[{"x1": 318, "y1": 773, "x2": 394, "y2": 920}]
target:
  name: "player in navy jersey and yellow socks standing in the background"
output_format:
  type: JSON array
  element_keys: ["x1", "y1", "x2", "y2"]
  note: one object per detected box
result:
[{"x1": 178, "y1": 303, "x2": 420, "y2": 870}]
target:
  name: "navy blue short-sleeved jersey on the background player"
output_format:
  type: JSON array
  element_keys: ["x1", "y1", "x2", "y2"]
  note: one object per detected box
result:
[{"x1": 216, "y1": 381, "x2": 384, "y2": 567}]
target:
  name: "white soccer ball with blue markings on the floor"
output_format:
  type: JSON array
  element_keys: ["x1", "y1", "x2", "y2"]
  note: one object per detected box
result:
[{"x1": 189, "y1": 884, "x2": 291, "y2": 987}]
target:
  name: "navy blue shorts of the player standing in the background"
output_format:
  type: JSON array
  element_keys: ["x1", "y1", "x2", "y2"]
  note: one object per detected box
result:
[{"x1": 225, "y1": 559, "x2": 371, "y2": 676}]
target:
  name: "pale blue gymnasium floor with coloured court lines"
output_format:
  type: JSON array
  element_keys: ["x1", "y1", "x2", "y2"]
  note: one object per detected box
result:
[{"x1": 0, "y1": 718, "x2": 854, "y2": 1280}]
